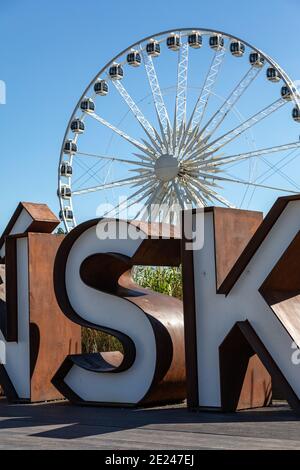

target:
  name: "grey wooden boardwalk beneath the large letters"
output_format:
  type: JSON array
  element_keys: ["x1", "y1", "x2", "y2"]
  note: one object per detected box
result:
[{"x1": 0, "y1": 399, "x2": 300, "y2": 450}]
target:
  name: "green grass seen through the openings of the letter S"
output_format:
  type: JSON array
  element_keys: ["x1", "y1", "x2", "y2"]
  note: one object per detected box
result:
[{"x1": 82, "y1": 266, "x2": 182, "y2": 353}]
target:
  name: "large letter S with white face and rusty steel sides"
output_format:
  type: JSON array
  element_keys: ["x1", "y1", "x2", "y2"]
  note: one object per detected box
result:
[{"x1": 53, "y1": 219, "x2": 186, "y2": 406}]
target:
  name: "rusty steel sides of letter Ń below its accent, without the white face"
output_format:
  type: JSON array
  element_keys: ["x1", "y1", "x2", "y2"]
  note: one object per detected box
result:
[{"x1": 0, "y1": 233, "x2": 81, "y2": 403}]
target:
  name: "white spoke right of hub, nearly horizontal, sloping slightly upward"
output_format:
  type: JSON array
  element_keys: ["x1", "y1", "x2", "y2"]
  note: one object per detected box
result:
[{"x1": 192, "y1": 142, "x2": 300, "y2": 168}]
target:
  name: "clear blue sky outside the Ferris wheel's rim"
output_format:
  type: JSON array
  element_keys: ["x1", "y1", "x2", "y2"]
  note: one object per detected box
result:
[{"x1": 0, "y1": 0, "x2": 300, "y2": 230}]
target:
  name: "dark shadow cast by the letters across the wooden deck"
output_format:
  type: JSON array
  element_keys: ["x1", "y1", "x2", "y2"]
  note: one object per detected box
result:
[{"x1": 0, "y1": 399, "x2": 300, "y2": 448}]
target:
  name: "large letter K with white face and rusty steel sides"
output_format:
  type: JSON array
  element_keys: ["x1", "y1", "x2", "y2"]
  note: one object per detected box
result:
[{"x1": 183, "y1": 196, "x2": 300, "y2": 411}]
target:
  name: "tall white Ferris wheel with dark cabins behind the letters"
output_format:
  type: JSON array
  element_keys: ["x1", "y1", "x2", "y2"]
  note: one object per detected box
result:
[{"x1": 58, "y1": 28, "x2": 300, "y2": 231}]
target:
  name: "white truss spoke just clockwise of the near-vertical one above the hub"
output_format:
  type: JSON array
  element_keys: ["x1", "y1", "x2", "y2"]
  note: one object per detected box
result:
[{"x1": 187, "y1": 46, "x2": 226, "y2": 135}]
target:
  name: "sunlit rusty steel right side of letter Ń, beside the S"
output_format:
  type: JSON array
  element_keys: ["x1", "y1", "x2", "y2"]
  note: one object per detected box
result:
[{"x1": 28, "y1": 233, "x2": 81, "y2": 402}]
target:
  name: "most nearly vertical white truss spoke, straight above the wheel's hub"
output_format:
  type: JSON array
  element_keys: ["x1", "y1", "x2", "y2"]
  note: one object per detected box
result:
[{"x1": 173, "y1": 38, "x2": 189, "y2": 134}]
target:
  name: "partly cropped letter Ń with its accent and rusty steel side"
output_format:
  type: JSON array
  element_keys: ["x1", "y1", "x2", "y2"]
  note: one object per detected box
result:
[{"x1": 0, "y1": 203, "x2": 81, "y2": 403}]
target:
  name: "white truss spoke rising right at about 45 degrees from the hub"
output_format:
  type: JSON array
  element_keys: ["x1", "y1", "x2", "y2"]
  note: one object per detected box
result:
[{"x1": 200, "y1": 67, "x2": 262, "y2": 139}]
